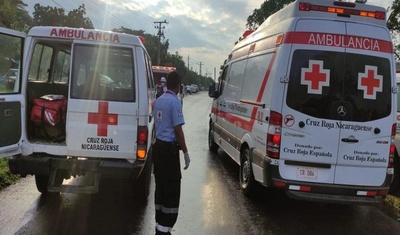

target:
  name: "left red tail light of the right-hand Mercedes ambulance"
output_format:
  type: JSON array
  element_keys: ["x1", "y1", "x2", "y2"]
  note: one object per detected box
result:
[{"x1": 267, "y1": 111, "x2": 282, "y2": 159}]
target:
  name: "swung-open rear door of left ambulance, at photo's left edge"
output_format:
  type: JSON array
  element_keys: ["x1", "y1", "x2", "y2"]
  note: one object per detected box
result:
[{"x1": 0, "y1": 28, "x2": 25, "y2": 157}]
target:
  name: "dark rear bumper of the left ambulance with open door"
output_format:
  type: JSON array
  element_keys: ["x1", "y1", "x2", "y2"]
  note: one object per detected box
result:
[{"x1": 9, "y1": 155, "x2": 146, "y2": 179}]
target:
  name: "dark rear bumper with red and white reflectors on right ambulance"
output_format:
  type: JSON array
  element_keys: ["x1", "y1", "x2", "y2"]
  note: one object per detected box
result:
[{"x1": 268, "y1": 164, "x2": 392, "y2": 205}]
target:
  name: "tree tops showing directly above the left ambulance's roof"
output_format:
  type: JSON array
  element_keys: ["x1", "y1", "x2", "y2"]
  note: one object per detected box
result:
[{"x1": 33, "y1": 3, "x2": 93, "y2": 29}]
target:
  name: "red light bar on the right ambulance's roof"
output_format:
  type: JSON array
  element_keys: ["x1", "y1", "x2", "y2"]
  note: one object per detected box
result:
[{"x1": 299, "y1": 2, "x2": 386, "y2": 20}]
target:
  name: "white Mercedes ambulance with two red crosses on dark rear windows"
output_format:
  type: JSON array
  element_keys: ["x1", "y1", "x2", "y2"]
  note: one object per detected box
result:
[{"x1": 209, "y1": 0, "x2": 397, "y2": 204}]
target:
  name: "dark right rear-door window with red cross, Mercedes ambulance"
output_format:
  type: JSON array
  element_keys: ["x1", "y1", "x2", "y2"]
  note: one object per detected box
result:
[{"x1": 343, "y1": 53, "x2": 392, "y2": 122}]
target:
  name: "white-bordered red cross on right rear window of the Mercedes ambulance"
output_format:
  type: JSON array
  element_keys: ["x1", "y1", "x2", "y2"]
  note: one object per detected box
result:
[{"x1": 357, "y1": 65, "x2": 383, "y2": 100}]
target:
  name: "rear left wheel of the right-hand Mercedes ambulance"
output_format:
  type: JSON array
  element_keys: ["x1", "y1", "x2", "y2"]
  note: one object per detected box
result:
[{"x1": 239, "y1": 148, "x2": 256, "y2": 196}]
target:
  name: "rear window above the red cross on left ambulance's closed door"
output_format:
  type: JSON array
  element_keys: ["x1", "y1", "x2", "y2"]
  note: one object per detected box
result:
[{"x1": 71, "y1": 45, "x2": 135, "y2": 102}]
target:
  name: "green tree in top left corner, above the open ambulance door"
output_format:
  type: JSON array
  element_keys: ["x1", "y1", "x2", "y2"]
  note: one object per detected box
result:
[{"x1": 0, "y1": 0, "x2": 31, "y2": 32}]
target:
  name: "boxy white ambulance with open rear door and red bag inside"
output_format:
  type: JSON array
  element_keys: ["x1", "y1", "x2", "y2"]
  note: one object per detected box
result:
[{"x1": 0, "y1": 26, "x2": 155, "y2": 198}]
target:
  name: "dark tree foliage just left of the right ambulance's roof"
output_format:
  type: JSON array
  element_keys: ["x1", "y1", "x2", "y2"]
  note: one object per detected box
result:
[{"x1": 246, "y1": 0, "x2": 294, "y2": 30}]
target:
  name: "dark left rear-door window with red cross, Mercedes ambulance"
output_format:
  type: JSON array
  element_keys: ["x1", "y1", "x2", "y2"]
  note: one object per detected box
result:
[{"x1": 286, "y1": 50, "x2": 344, "y2": 119}]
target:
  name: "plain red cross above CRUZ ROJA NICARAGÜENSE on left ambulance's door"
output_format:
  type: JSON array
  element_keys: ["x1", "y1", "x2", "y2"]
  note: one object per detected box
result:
[{"x1": 88, "y1": 101, "x2": 118, "y2": 136}]
